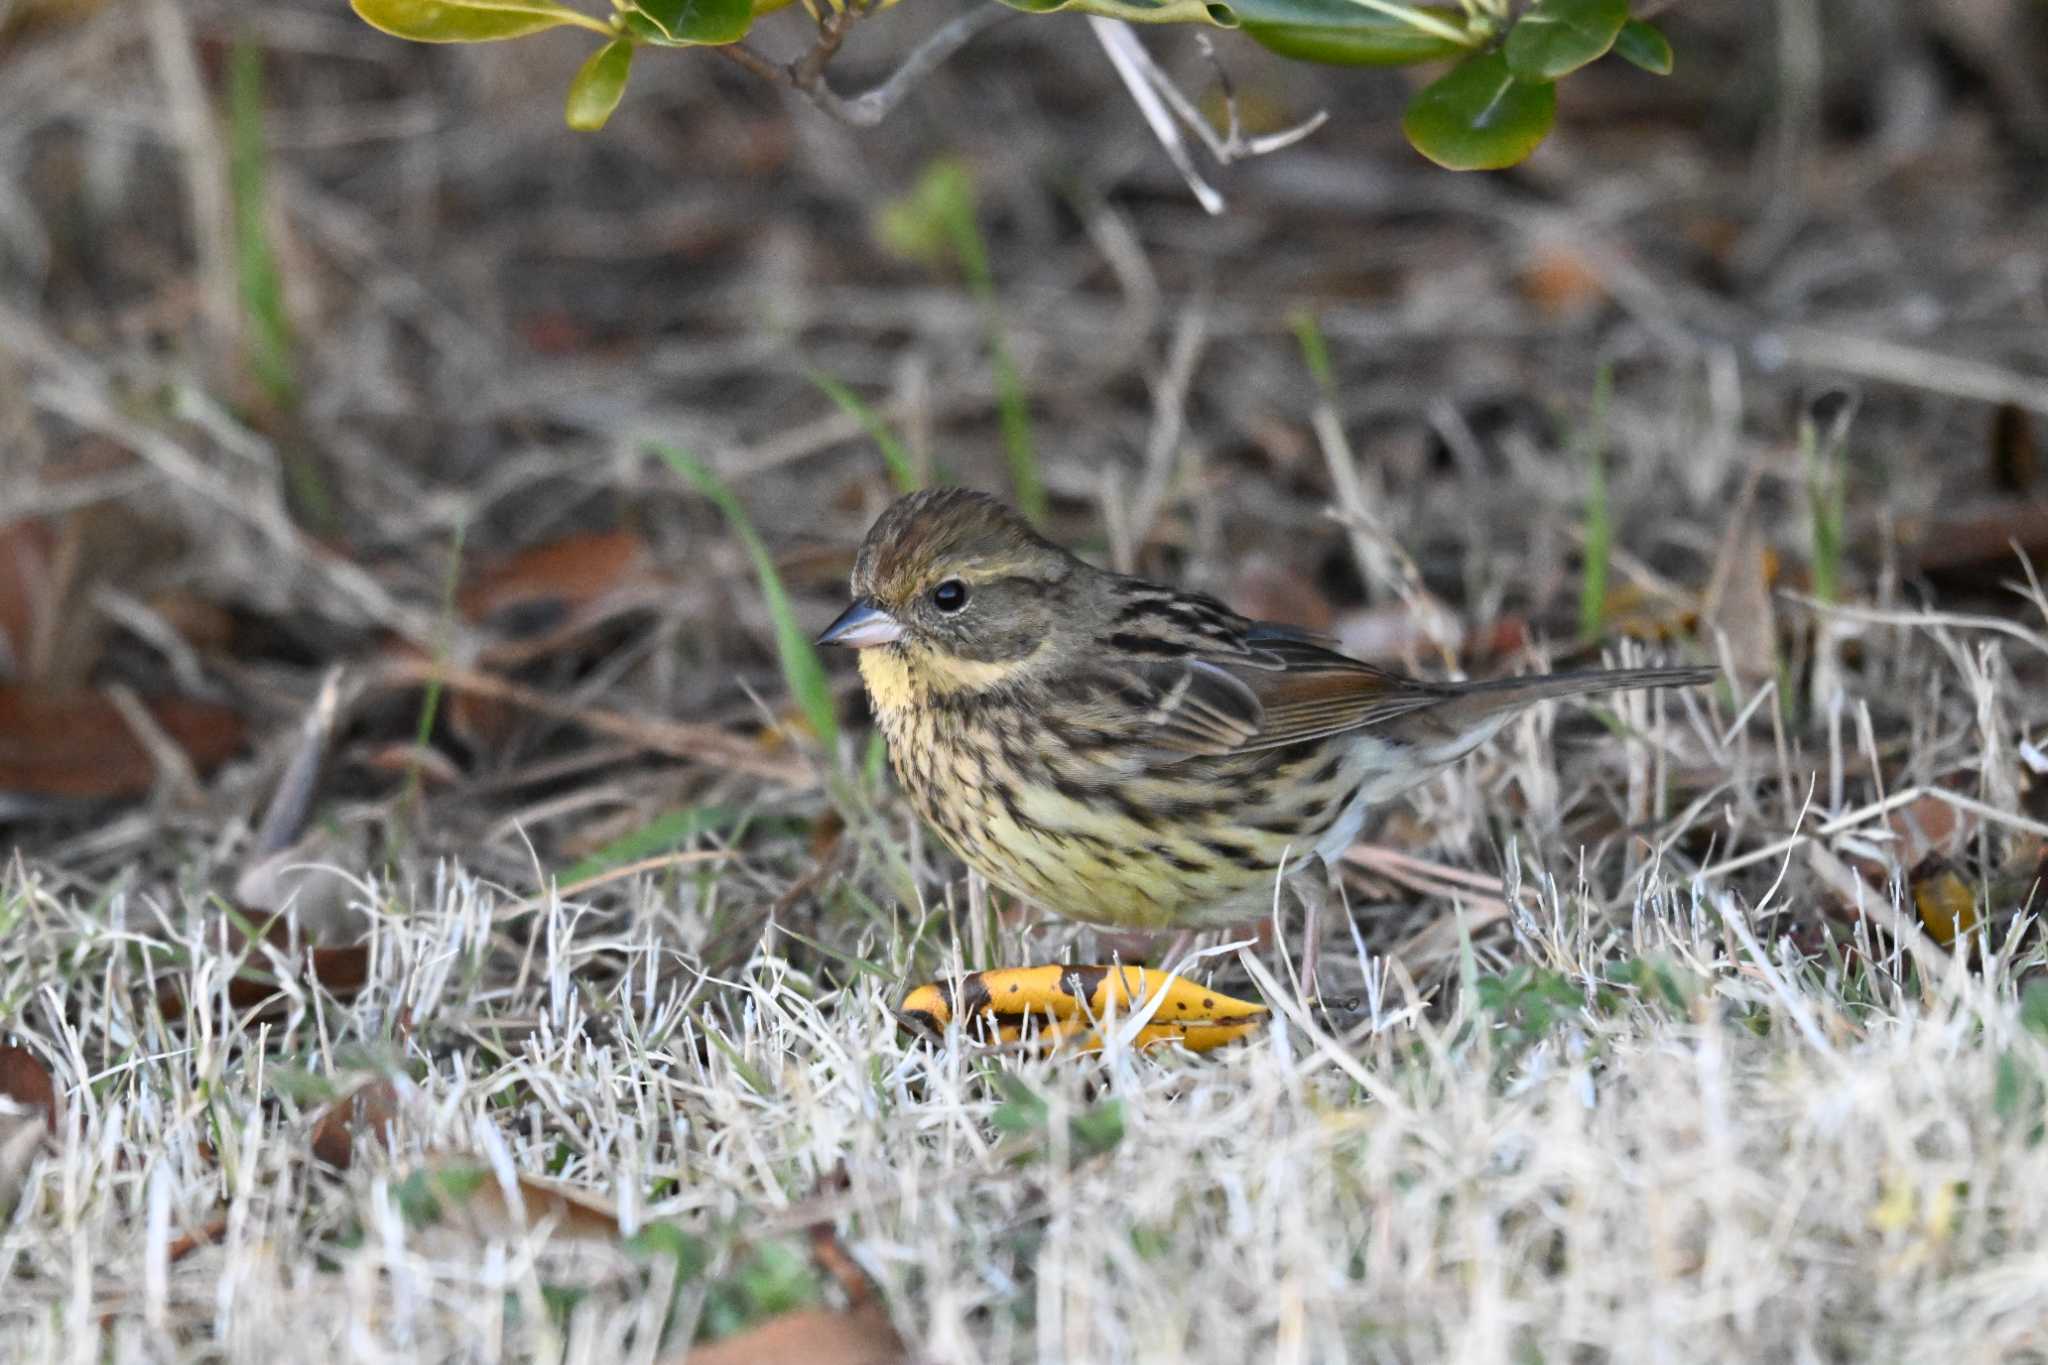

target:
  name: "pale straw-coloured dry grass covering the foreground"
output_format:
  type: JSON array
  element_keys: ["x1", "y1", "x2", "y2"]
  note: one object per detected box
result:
[{"x1": 12, "y1": 712, "x2": 2048, "y2": 1361}]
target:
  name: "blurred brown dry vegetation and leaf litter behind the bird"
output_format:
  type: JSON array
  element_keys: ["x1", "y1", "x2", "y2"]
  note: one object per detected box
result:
[{"x1": 0, "y1": 0, "x2": 2048, "y2": 896}]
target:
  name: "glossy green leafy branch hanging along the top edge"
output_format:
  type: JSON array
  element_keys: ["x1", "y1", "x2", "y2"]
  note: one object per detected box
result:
[{"x1": 350, "y1": 0, "x2": 1671, "y2": 170}]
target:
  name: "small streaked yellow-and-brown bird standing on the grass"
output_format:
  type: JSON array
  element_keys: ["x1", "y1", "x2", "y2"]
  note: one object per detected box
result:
[{"x1": 819, "y1": 489, "x2": 1714, "y2": 945}]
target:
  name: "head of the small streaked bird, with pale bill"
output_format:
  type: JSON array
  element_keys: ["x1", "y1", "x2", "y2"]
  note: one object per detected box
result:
[{"x1": 817, "y1": 489, "x2": 1092, "y2": 706}]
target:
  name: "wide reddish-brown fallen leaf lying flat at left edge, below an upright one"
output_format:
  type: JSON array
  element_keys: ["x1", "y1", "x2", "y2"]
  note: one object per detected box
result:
[{"x1": 0, "y1": 688, "x2": 246, "y2": 800}]
